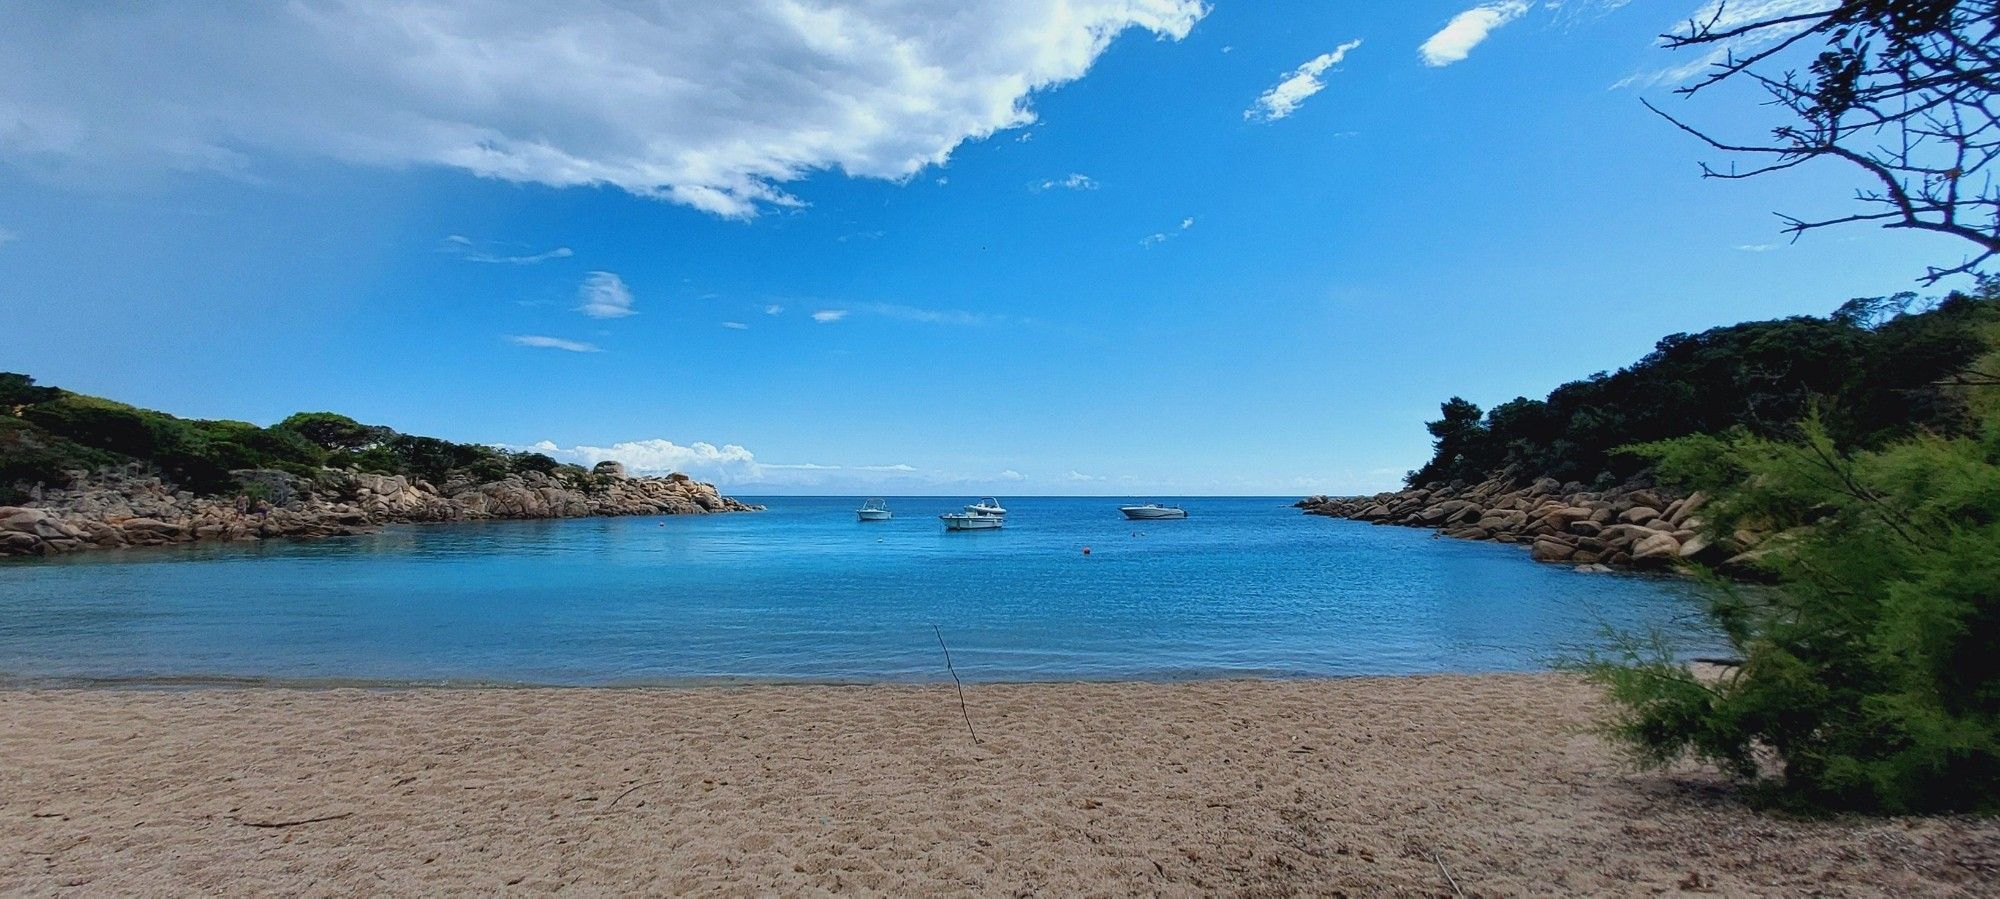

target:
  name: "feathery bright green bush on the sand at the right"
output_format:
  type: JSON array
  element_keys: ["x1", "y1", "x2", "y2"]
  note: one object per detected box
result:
[{"x1": 1586, "y1": 399, "x2": 2000, "y2": 813}]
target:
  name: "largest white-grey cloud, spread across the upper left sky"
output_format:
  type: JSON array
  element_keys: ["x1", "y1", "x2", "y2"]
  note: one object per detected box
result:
[{"x1": 0, "y1": 0, "x2": 1208, "y2": 218}]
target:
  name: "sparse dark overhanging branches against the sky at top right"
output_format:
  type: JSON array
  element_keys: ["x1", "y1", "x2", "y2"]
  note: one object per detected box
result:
[{"x1": 1648, "y1": 0, "x2": 2000, "y2": 284}]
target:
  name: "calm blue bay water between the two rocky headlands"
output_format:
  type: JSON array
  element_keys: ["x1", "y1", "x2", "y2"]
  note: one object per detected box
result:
[{"x1": 0, "y1": 497, "x2": 1714, "y2": 683}]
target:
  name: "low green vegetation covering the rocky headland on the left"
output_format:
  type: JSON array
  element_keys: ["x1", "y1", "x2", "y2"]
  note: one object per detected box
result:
[{"x1": 0, "y1": 372, "x2": 590, "y2": 505}]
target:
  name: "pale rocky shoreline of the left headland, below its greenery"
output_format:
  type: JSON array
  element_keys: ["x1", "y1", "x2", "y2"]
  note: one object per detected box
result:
[{"x1": 0, "y1": 465, "x2": 760, "y2": 555}]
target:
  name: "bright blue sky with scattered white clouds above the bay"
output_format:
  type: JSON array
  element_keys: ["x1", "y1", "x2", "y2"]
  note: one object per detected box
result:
[{"x1": 0, "y1": 0, "x2": 1958, "y2": 495}]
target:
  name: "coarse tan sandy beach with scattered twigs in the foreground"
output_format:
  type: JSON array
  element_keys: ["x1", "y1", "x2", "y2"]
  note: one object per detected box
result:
[{"x1": 0, "y1": 675, "x2": 2000, "y2": 895}]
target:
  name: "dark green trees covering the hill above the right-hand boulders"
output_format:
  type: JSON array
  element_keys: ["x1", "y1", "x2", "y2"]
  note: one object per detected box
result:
[{"x1": 1408, "y1": 284, "x2": 2000, "y2": 485}]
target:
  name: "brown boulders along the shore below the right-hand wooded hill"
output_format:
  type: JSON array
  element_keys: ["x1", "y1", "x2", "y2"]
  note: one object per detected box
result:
[{"x1": 1298, "y1": 477, "x2": 1756, "y2": 569}]
